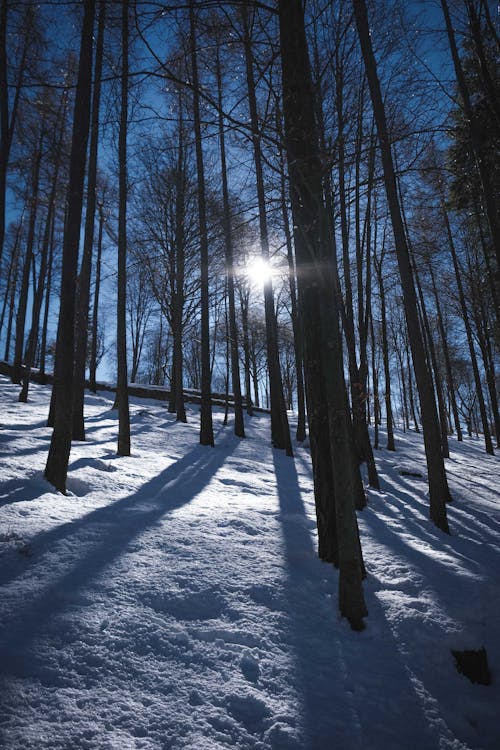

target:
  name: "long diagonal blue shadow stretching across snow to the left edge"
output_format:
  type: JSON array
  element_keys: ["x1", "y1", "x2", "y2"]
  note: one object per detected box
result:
[{"x1": 0, "y1": 436, "x2": 238, "y2": 674}]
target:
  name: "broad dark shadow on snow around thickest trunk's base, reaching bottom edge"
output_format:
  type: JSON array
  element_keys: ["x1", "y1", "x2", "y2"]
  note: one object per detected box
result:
[{"x1": 273, "y1": 451, "x2": 446, "y2": 750}]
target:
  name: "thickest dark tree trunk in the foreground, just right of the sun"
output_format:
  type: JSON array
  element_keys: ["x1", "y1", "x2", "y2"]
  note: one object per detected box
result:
[{"x1": 278, "y1": 0, "x2": 367, "y2": 629}]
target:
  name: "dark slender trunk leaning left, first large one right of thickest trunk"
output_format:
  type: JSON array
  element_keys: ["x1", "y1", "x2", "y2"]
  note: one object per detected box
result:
[{"x1": 353, "y1": 0, "x2": 450, "y2": 533}]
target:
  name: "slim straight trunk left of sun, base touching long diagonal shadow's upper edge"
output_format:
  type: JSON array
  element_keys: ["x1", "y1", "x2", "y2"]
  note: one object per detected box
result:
[{"x1": 189, "y1": 0, "x2": 214, "y2": 446}]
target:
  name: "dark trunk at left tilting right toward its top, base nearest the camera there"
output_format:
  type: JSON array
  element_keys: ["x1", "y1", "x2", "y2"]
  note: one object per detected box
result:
[{"x1": 45, "y1": 0, "x2": 95, "y2": 492}]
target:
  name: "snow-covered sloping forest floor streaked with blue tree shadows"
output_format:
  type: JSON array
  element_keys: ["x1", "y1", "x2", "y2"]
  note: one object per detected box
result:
[{"x1": 0, "y1": 377, "x2": 500, "y2": 750}]
